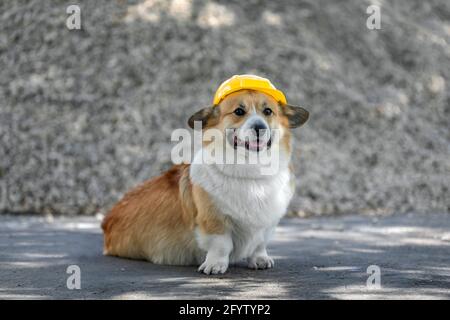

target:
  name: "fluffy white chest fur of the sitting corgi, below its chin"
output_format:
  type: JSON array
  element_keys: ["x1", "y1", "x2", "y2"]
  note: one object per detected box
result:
[{"x1": 190, "y1": 151, "x2": 293, "y2": 261}]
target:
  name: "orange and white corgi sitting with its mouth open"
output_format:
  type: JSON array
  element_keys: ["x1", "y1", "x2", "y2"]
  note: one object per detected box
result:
[{"x1": 102, "y1": 78, "x2": 309, "y2": 274}]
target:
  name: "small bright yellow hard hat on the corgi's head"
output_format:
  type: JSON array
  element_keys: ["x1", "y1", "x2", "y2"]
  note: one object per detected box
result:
[{"x1": 213, "y1": 74, "x2": 287, "y2": 105}]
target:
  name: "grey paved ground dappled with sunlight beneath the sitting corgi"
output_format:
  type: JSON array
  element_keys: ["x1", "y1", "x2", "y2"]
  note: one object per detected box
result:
[{"x1": 0, "y1": 214, "x2": 450, "y2": 299}]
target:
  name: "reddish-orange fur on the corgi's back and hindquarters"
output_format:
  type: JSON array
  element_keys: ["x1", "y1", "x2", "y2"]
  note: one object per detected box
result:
[{"x1": 102, "y1": 165, "x2": 198, "y2": 264}]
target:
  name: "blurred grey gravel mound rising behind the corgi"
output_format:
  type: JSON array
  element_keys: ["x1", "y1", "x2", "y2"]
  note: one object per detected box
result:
[{"x1": 0, "y1": 0, "x2": 450, "y2": 215}]
